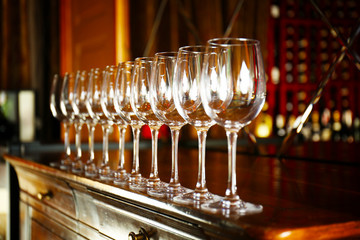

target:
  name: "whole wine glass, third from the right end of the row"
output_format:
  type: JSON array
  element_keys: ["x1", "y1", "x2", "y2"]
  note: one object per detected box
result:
[{"x1": 148, "y1": 52, "x2": 186, "y2": 199}]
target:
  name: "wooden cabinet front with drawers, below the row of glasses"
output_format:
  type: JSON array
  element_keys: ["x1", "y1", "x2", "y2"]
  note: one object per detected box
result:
[{"x1": 6, "y1": 153, "x2": 248, "y2": 240}]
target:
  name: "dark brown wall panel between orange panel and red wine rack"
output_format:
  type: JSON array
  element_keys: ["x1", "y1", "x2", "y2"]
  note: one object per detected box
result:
[{"x1": 129, "y1": 0, "x2": 270, "y2": 57}]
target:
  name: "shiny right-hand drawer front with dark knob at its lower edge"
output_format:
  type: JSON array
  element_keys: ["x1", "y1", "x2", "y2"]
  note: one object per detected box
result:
[{"x1": 90, "y1": 194, "x2": 206, "y2": 240}]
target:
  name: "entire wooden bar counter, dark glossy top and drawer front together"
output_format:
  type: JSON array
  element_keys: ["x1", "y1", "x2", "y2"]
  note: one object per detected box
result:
[{"x1": 4, "y1": 140, "x2": 360, "y2": 239}]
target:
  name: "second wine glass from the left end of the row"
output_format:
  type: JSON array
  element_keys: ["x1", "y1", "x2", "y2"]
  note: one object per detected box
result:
[{"x1": 60, "y1": 71, "x2": 83, "y2": 173}]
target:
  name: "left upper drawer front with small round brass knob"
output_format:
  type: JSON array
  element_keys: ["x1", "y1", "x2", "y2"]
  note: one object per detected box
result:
[{"x1": 16, "y1": 167, "x2": 76, "y2": 219}]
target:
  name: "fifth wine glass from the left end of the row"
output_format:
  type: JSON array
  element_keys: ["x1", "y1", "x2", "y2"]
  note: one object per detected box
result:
[{"x1": 101, "y1": 65, "x2": 128, "y2": 184}]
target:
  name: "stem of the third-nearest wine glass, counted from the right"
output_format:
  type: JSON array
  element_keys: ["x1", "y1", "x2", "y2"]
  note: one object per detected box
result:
[{"x1": 169, "y1": 129, "x2": 180, "y2": 187}]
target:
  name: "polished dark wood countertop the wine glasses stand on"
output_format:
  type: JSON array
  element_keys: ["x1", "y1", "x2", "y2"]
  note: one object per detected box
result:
[{"x1": 4, "y1": 140, "x2": 360, "y2": 239}]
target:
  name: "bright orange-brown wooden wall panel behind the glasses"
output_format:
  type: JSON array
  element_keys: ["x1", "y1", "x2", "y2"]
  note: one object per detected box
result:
[{"x1": 61, "y1": 0, "x2": 116, "y2": 72}]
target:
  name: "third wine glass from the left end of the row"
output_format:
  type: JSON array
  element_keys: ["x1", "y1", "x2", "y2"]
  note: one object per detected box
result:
[{"x1": 72, "y1": 71, "x2": 98, "y2": 177}]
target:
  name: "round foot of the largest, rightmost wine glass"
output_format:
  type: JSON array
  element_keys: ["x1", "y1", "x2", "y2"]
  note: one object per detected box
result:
[{"x1": 201, "y1": 199, "x2": 263, "y2": 218}]
